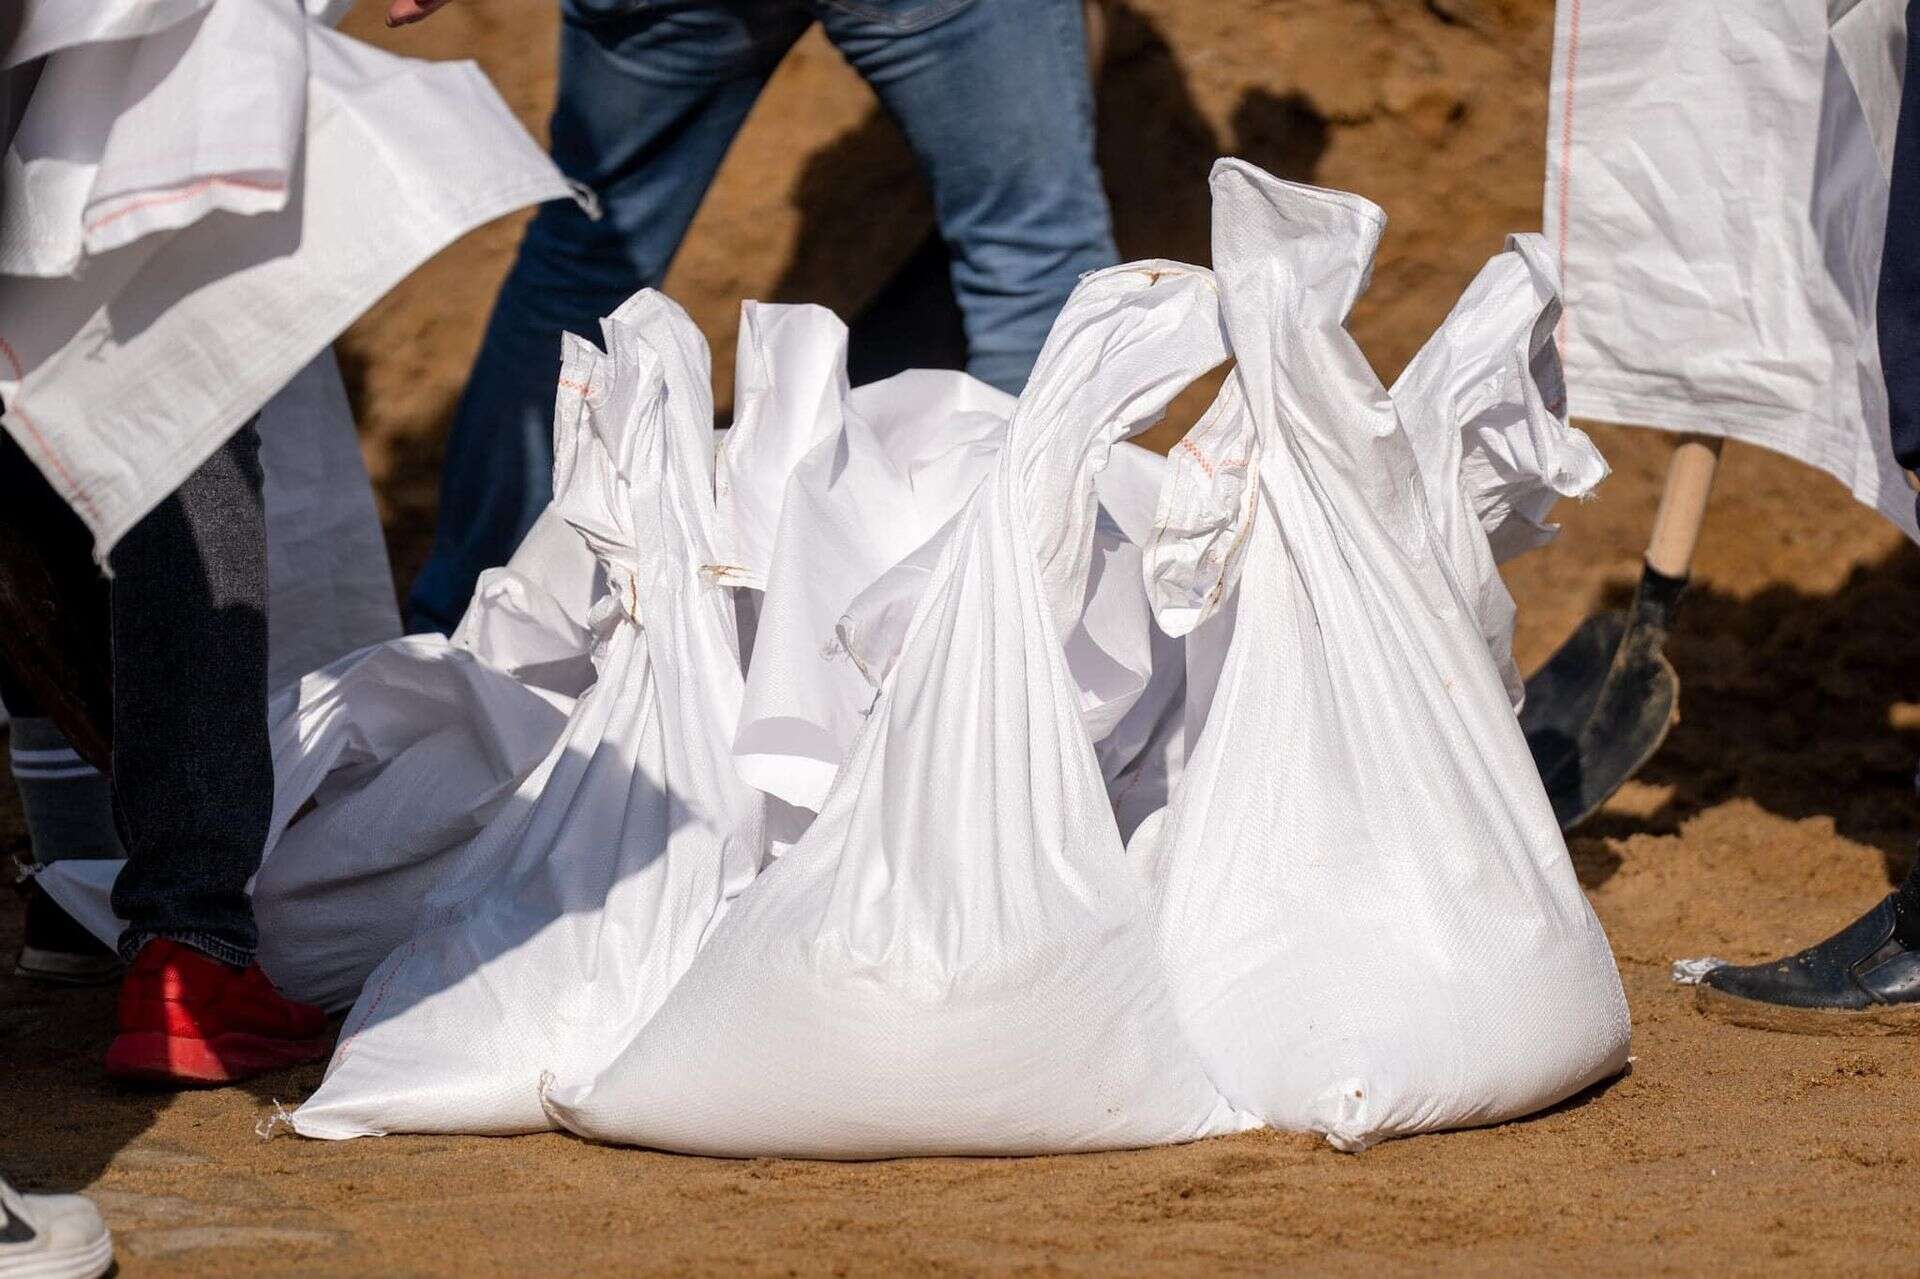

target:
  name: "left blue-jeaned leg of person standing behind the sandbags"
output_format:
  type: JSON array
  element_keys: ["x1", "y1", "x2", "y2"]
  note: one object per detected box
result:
[{"x1": 407, "y1": 0, "x2": 810, "y2": 630}]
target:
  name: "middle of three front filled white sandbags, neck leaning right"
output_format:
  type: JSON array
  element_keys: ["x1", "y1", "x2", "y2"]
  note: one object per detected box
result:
[{"x1": 547, "y1": 263, "x2": 1246, "y2": 1158}]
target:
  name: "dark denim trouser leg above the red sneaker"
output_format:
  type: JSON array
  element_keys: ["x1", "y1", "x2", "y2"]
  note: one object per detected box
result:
[{"x1": 109, "y1": 422, "x2": 273, "y2": 964}]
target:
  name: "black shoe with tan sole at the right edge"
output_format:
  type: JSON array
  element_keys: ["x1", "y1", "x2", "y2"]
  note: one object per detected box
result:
[{"x1": 1693, "y1": 889, "x2": 1920, "y2": 1035}]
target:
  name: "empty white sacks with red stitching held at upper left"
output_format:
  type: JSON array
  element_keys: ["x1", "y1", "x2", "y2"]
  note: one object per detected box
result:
[{"x1": 0, "y1": 0, "x2": 568, "y2": 557}]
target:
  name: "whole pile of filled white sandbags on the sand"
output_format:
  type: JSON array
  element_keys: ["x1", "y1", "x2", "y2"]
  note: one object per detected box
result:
[{"x1": 41, "y1": 161, "x2": 1628, "y2": 1158}]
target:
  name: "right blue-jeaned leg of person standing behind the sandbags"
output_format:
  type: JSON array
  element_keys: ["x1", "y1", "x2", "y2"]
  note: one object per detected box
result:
[{"x1": 810, "y1": 0, "x2": 1117, "y2": 392}]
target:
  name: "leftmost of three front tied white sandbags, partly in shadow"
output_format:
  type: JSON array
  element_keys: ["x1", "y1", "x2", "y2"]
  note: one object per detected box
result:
[{"x1": 292, "y1": 292, "x2": 764, "y2": 1137}]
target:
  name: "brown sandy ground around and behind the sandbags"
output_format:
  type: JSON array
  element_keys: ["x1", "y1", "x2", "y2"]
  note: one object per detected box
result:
[{"x1": 0, "y1": 0, "x2": 1920, "y2": 1275}]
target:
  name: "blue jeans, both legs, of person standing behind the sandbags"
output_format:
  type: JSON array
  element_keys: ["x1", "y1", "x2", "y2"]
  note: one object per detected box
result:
[{"x1": 409, "y1": 0, "x2": 1117, "y2": 630}]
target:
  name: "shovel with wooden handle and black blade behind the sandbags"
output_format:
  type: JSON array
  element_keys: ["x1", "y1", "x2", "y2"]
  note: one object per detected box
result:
[{"x1": 1521, "y1": 436, "x2": 1720, "y2": 830}]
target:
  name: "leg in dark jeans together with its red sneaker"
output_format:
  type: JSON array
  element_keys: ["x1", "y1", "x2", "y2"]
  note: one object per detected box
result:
[{"x1": 106, "y1": 422, "x2": 330, "y2": 1085}]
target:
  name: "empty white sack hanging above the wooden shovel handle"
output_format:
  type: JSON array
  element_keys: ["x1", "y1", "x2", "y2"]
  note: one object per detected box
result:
[{"x1": 1544, "y1": 0, "x2": 1920, "y2": 538}]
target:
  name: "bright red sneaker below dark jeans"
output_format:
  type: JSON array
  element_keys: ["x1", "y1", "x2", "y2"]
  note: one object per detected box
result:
[{"x1": 108, "y1": 937, "x2": 332, "y2": 1085}]
